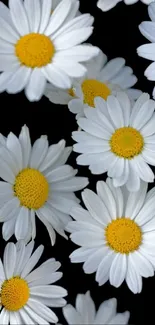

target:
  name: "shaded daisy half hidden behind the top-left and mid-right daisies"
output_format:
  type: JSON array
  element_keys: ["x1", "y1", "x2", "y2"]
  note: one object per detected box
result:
[{"x1": 45, "y1": 50, "x2": 141, "y2": 118}]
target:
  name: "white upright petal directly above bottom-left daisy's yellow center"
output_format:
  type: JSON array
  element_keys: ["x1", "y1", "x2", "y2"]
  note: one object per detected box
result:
[{"x1": 3, "y1": 243, "x2": 16, "y2": 279}]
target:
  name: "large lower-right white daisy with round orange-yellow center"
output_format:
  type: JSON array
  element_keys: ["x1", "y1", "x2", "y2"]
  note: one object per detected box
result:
[{"x1": 67, "y1": 178, "x2": 155, "y2": 293}]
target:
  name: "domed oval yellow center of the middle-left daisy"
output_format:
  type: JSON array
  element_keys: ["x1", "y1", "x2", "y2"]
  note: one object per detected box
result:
[{"x1": 13, "y1": 168, "x2": 49, "y2": 210}]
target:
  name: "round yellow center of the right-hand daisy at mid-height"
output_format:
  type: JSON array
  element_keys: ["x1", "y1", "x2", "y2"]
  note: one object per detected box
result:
[{"x1": 110, "y1": 127, "x2": 144, "y2": 159}]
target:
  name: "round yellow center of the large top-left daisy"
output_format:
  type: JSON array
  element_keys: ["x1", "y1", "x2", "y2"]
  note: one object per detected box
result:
[{"x1": 15, "y1": 33, "x2": 55, "y2": 68}]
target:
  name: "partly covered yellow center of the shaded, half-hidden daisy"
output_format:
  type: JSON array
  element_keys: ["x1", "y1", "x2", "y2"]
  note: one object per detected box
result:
[{"x1": 82, "y1": 79, "x2": 111, "y2": 107}]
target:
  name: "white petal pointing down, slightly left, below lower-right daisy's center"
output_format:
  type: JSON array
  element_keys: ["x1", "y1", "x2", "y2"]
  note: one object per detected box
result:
[{"x1": 109, "y1": 254, "x2": 127, "y2": 288}]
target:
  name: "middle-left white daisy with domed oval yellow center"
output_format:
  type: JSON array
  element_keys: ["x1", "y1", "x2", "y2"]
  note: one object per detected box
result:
[{"x1": 0, "y1": 126, "x2": 88, "y2": 245}]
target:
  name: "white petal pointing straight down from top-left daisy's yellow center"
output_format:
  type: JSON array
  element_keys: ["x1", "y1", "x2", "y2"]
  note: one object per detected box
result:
[{"x1": 25, "y1": 68, "x2": 46, "y2": 102}]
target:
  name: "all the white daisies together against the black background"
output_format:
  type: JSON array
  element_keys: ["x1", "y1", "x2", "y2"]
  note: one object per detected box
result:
[{"x1": 0, "y1": 0, "x2": 155, "y2": 325}]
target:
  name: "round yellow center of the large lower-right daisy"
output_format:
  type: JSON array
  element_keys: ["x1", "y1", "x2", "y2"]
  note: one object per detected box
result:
[{"x1": 105, "y1": 218, "x2": 142, "y2": 254}]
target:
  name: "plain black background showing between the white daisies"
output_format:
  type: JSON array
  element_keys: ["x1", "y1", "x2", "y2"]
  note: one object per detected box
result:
[{"x1": 0, "y1": 0, "x2": 155, "y2": 324}]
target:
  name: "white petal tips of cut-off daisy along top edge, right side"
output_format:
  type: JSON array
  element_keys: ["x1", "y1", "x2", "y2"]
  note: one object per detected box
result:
[{"x1": 97, "y1": 0, "x2": 154, "y2": 11}]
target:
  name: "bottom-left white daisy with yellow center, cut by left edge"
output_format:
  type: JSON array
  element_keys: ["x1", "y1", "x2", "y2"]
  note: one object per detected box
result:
[{"x1": 0, "y1": 241, "x2": 67, "y2": 325}]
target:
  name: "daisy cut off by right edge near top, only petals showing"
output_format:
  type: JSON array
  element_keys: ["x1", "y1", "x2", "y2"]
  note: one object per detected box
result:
[{"x1": 137, "y1": 3, "x2": 155, "y2": 98}]
